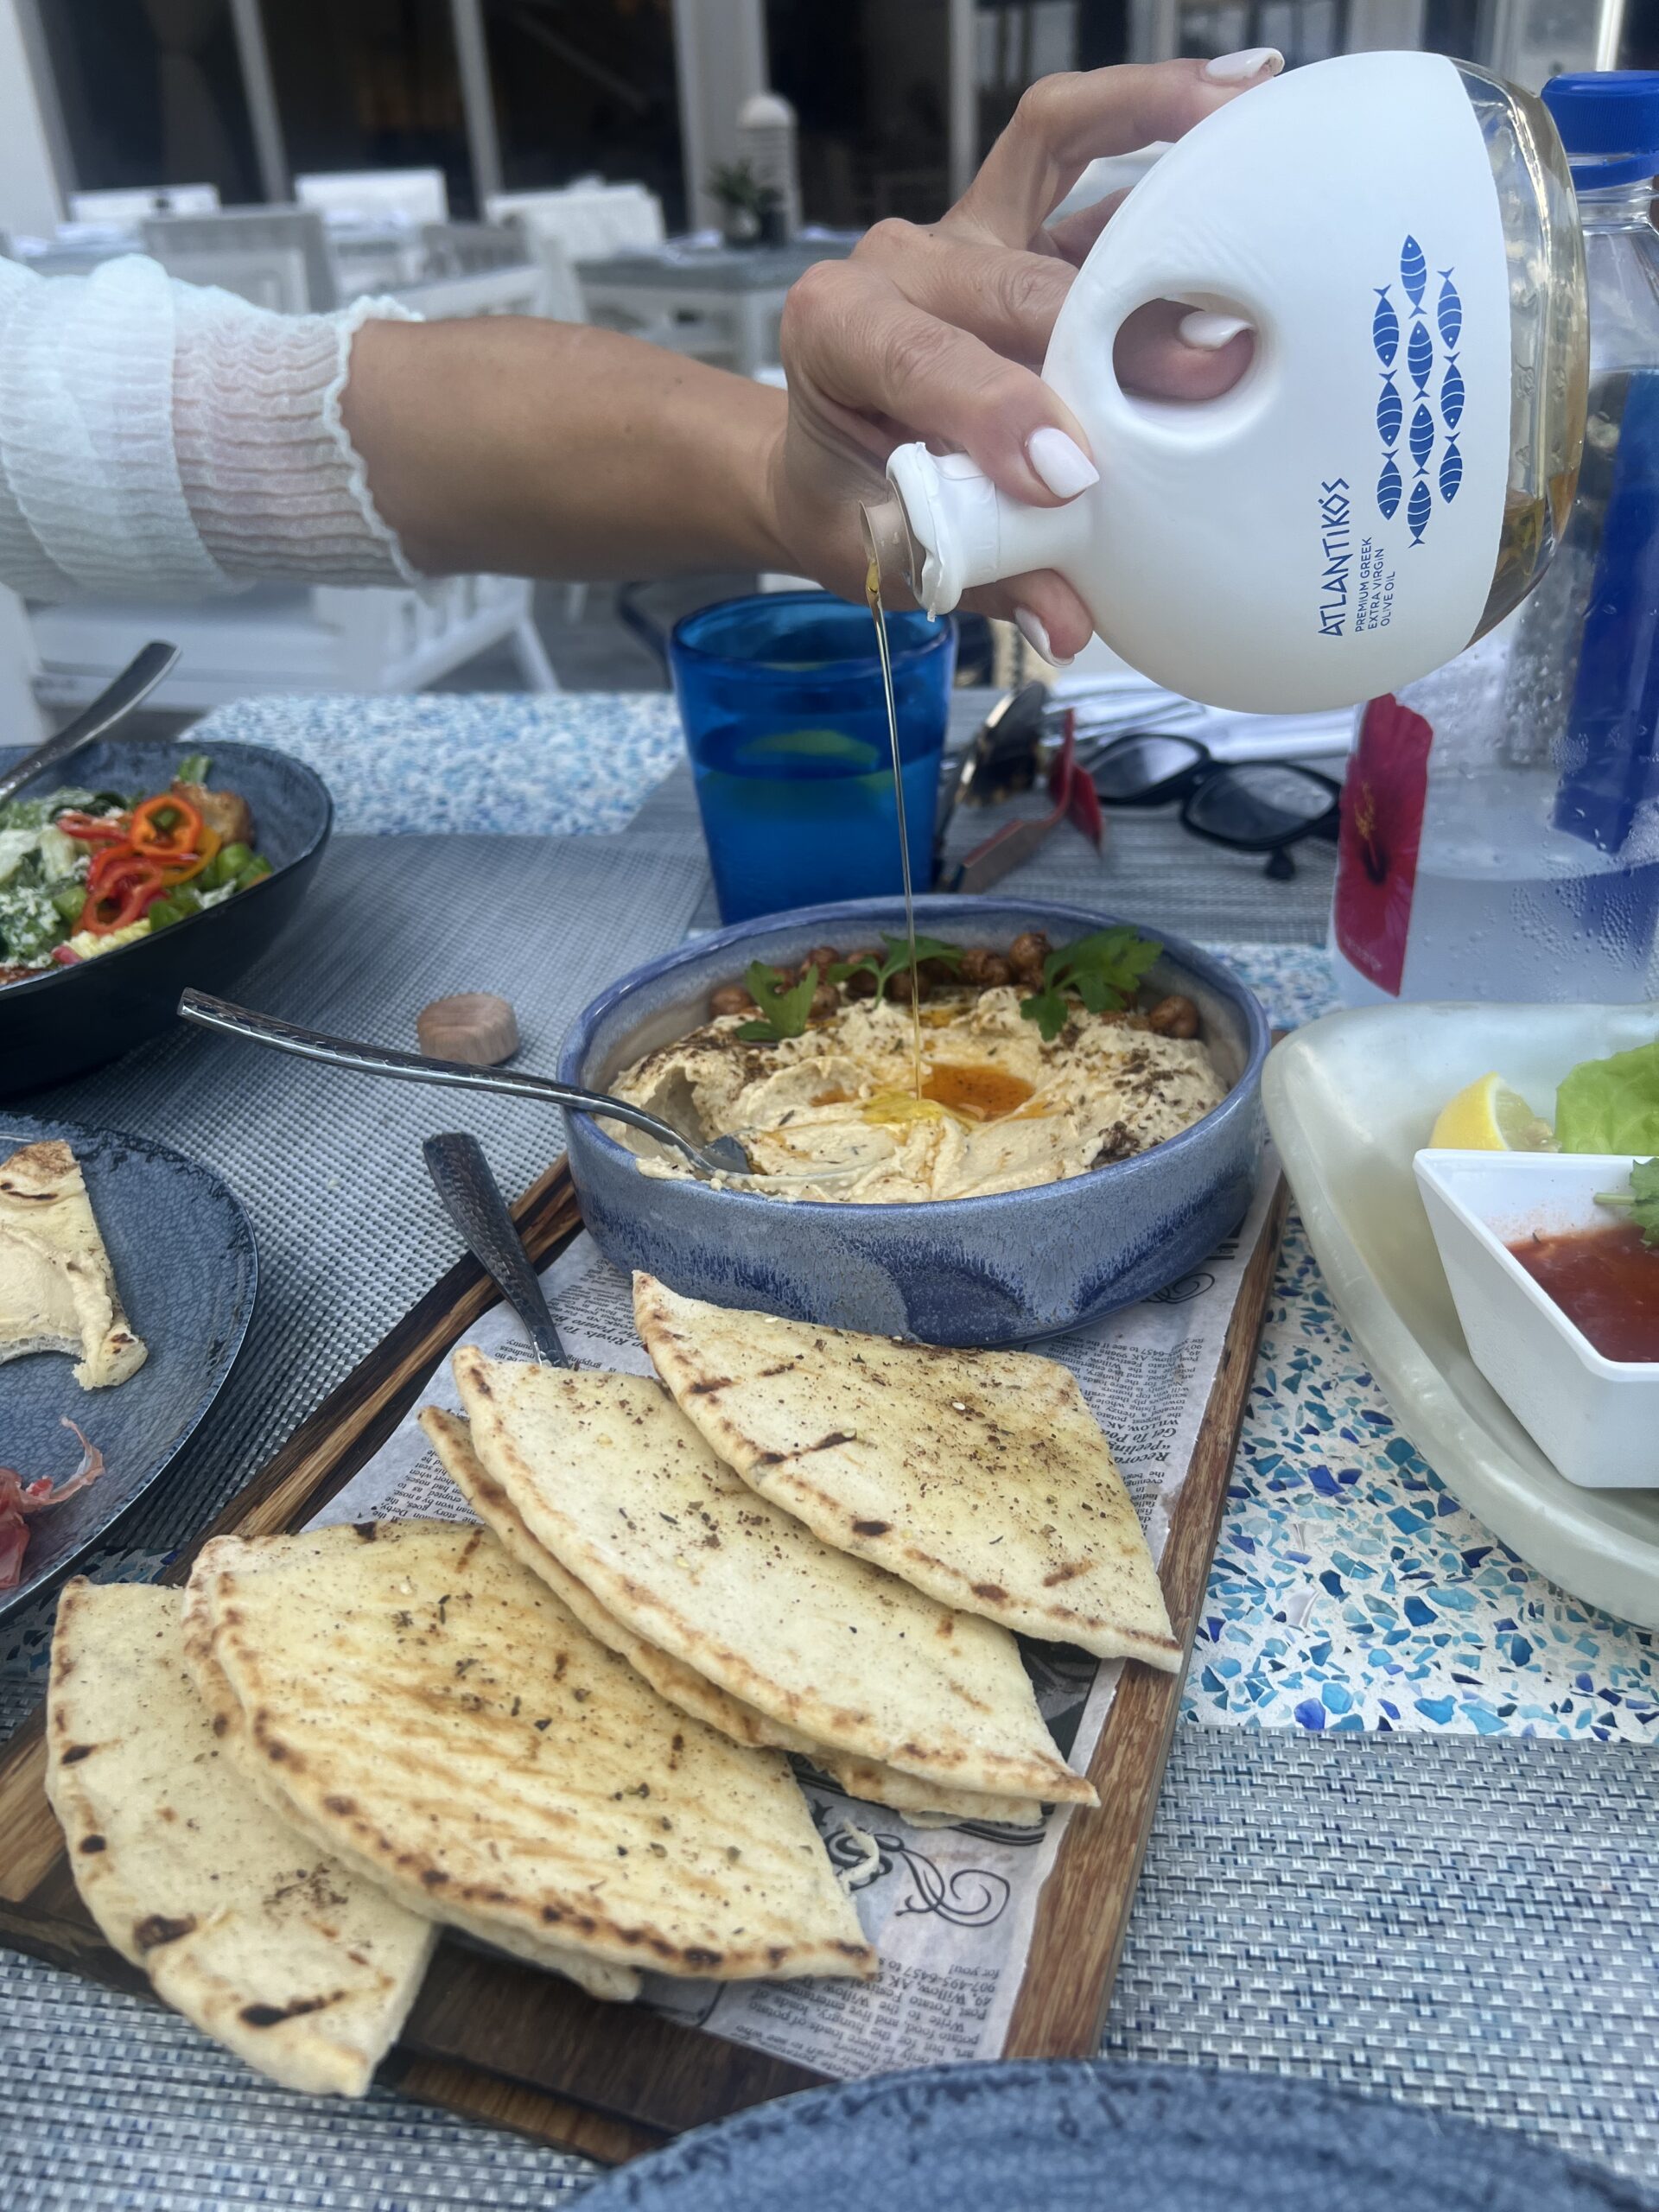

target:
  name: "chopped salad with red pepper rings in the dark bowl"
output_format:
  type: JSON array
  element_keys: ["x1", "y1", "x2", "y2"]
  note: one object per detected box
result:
[{"x1": 0, "y1": 752, "x2": 270, "y2": 984}]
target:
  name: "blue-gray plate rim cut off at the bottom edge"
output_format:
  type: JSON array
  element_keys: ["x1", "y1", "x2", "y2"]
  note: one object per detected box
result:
[{"x1": 582, "y1": 2062, "x2": 1655, "y2": 2212}]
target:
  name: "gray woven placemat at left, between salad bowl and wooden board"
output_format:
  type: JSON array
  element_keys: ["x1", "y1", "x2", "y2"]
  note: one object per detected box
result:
[{"x1": 0, "y1": 836, "x2": 703, "y2": 1730}]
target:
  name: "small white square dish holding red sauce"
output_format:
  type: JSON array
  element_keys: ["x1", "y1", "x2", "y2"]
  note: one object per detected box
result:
[{"x1": 1415, "y1": 1150, "x2": 1659, "y2": 1491}]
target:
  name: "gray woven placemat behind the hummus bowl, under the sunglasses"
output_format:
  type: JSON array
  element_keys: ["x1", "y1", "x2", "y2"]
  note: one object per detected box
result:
[{"x1": 621, "y1": 763, "x2": 1336, "y2": 944}]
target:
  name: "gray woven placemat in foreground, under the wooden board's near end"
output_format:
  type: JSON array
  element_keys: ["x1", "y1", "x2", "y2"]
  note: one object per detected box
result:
[{"x1": 0, "y1": 1726, "x2": 1659, "y2": 2212}]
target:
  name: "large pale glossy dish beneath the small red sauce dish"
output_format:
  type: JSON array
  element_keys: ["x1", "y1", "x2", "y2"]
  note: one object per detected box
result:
[{"x1": 1261, "y1": 1004, "x2": 1659, "y2": 1628}]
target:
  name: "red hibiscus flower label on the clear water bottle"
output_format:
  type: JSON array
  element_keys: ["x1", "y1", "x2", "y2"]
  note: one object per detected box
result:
[{"x1": 1334, "y1": 692, "x2": 1433, "y2": 998}]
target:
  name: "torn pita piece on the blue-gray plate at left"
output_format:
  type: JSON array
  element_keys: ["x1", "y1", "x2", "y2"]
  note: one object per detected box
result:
[{"x1": 0, "y1": 1137, "x2": 149, "y2": 1389}]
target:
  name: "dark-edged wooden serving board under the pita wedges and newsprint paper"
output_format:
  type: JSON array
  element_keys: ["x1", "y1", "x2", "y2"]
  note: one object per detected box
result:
[{"x1": 0, "y1": 1159, "x2": 1285, "y2": 2164}]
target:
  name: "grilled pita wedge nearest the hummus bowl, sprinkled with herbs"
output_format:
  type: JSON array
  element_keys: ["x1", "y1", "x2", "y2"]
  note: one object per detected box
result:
[{"x1": 635, "y1": 1274, "x2": 1181, "y2": 1670}]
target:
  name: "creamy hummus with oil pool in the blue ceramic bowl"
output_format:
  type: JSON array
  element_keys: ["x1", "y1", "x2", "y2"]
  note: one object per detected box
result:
[{"x1": 619, "y1": 988, "x2": 1228, "y2": 1205}]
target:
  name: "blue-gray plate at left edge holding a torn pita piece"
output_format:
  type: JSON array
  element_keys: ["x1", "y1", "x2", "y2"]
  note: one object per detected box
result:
[{"x1": 0, "y1": 1106, "x2": 259, "y2": 1619}]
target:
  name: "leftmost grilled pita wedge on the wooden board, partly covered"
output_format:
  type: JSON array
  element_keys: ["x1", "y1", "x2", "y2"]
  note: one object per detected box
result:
[{"x1": 47, "y1": 1580, "x2": 434, "y2": 2097}]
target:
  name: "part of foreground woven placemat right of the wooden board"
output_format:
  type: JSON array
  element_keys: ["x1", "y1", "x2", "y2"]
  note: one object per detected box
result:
[{"x1": 1102, "y1": 1726, "x2": 1659, "y2": 2183}]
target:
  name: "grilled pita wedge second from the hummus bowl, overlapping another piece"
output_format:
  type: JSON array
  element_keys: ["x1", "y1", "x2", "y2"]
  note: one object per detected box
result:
[{"x1": 454, "y1": 1344, "x2": 1095, "y2": 1805}]
